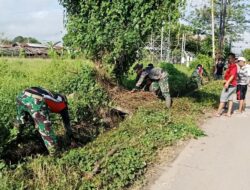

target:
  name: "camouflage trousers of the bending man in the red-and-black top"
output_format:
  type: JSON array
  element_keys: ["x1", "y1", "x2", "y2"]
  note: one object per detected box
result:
[{"x1": 16, "y1": 92, "x2": 57, "y2": 155}]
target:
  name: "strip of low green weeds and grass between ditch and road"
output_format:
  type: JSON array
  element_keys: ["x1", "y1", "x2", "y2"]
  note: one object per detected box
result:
[{"x1": 1, "y1": 100, "x2": 206, "y2": 189}]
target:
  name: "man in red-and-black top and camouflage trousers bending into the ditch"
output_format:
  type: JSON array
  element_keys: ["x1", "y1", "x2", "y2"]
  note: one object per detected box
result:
[{"x1": 16, "y1": 87, "x2": 73, "y2": 155}]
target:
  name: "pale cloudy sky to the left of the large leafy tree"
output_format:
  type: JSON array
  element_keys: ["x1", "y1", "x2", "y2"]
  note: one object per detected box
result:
[{"x1": 0, "y1": 0, "x2": 64, "y2": 42}]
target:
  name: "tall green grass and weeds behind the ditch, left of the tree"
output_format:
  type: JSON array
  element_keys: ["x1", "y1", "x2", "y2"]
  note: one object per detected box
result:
[{"x1": 0, "y1": 58, "x2": 107, "y2": 153}]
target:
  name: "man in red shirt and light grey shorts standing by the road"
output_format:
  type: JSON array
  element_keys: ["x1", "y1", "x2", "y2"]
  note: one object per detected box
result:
[{"x1": 216, "y1": 53, "x2": 237, "y2": 117}]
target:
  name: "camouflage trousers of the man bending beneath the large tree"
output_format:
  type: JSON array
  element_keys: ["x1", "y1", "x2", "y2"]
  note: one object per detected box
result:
[{"x1": 149, "y1": 76, "x2": 170, "y2": 99}]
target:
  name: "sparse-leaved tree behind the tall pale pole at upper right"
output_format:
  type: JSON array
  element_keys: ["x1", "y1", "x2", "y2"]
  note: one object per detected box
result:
[{"x1": 191, "y1": 0, "x2": 250, "y2": 53}]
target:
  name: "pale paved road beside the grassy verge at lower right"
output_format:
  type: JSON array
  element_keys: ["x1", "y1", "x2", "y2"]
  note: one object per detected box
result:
[{"x1": 145, "y1": 91, "x2": 250, "y2": 190}]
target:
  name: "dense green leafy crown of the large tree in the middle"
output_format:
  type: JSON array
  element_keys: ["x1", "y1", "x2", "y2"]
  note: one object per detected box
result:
[{"x1": 59, "y1": 0, "x2": 182, "y2": 76}]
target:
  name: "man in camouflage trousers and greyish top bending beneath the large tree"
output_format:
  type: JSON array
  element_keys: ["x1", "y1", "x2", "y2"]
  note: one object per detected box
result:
[{"x1": 131, "y1": 66, "x2": 171, "y2": 108}]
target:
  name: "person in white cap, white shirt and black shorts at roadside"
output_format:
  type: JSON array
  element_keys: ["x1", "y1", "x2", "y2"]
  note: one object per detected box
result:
[{"x1": 236, "y1": 57, "x2": 249, "y2": 113}]
